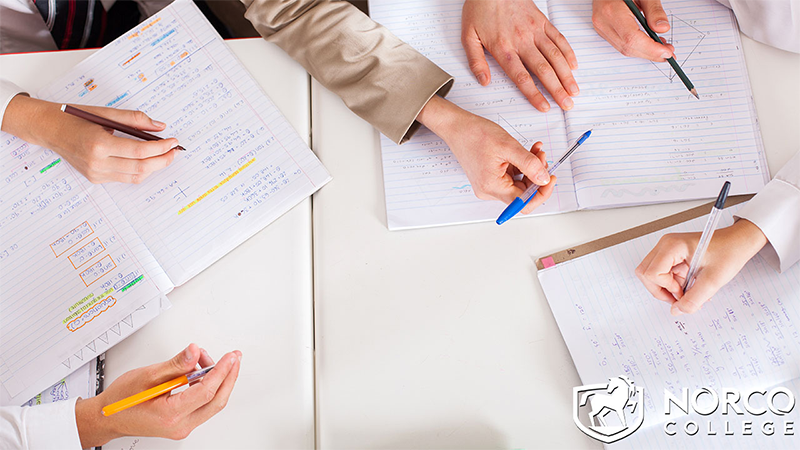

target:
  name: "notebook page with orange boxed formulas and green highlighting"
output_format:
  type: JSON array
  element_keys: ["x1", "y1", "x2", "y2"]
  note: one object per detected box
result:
[{"x1": 0, "y1": 133, "x2": 172, "y2": 405}]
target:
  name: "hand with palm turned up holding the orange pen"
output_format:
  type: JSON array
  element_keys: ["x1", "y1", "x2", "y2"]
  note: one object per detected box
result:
[{"x1": 75, "y1": 344, "x2": 242, "y2": 448}]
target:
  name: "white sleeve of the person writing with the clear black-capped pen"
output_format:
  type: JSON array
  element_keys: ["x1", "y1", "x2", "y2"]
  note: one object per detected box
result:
[{"x1": 736, "y1": 152, "x2": 800, "y2": 272}]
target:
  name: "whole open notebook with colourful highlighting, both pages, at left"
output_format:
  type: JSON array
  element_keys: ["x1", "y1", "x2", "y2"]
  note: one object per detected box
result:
[{"x1": 0, "y1": 1, "x2": 330, "y2": 405}]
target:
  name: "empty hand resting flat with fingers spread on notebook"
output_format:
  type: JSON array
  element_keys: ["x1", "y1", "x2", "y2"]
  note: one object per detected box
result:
[{"x1": 461, "y1": 0, "x2": 580, "y2": 111}]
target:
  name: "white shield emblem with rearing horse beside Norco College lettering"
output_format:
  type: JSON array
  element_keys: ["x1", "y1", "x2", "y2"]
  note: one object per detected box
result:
[{"x1": 572, "y1": 377, "x2": 644, "y2": 444}]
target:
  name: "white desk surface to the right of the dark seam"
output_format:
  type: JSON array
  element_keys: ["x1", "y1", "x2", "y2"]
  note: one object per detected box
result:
[{"x1": 311, "y1": 33, "x2": 800, "y2": 449}]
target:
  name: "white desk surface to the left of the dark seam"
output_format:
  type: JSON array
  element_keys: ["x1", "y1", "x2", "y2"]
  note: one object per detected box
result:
[{"x1": 0, "y1": 39, "x2": 314, "y2": 449}]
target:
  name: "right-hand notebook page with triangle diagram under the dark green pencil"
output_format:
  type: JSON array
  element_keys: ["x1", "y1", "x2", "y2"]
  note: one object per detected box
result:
[{"x1": 548, "y1": 0, "x2": 769, "y2": 208}]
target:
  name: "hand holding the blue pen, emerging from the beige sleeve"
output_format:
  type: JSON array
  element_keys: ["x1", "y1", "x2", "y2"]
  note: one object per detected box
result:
[{"x1": 417, "y1": 96, "x2": 556, "y2": 214}]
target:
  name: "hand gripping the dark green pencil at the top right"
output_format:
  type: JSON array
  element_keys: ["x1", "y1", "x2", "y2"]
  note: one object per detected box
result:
[{"x1": 592, "y1": 0, "x2": 675, "y2": 62}]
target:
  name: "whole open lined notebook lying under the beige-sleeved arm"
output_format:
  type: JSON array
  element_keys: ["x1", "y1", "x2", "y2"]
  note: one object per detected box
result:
[{"x1": 370, "y1": 0, "x2": 769, "y2": 229}]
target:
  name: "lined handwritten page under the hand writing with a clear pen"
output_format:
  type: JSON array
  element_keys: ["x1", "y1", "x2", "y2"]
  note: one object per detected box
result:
[{"x1": 539, "y1": 205, "x2": 800, "y2": 448}]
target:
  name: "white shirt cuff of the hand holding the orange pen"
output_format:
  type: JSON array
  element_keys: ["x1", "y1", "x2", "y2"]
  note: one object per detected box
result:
[{"x1": 0, "y1": 398, "x2": 81, "y2": 450}]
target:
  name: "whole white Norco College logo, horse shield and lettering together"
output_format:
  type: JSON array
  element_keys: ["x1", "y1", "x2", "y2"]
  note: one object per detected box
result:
[{"x1": 572, "y1": 376, "x2": 796, "y2": 444}]
